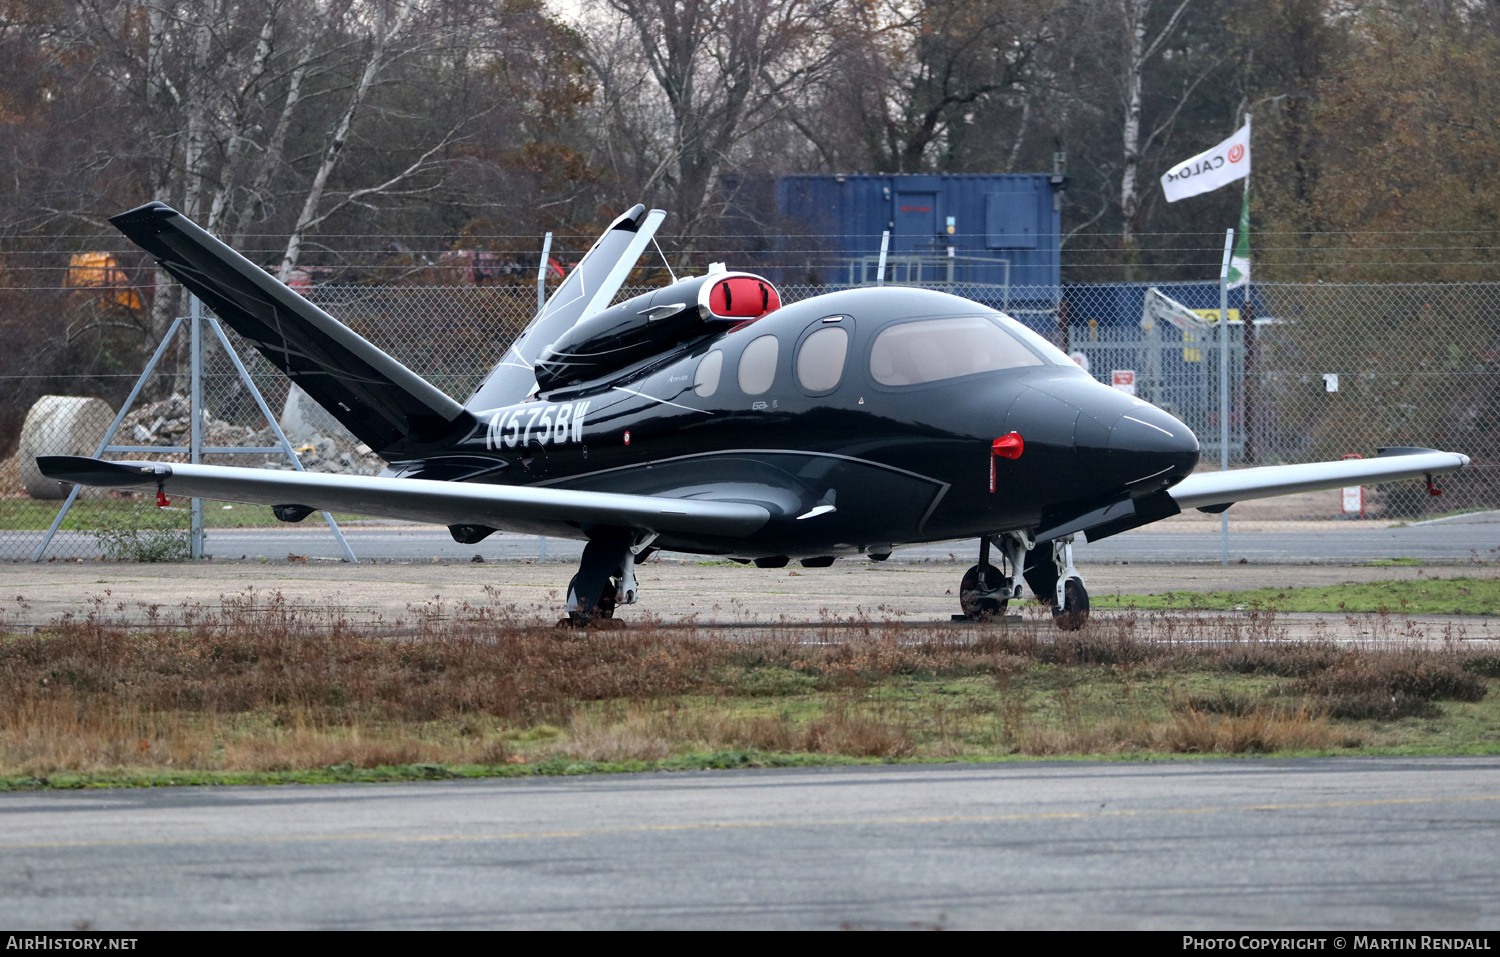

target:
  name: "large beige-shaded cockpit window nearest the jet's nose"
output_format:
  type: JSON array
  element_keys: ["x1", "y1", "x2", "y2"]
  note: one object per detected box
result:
[{"x1": 870, "y1": 315, "x2": 1043, "y2": 386}]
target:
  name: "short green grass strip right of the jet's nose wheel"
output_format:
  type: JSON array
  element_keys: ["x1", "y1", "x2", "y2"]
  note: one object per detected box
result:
[{"x1": 1091, "y1": 578, "x2": 1500, "y2": 615}]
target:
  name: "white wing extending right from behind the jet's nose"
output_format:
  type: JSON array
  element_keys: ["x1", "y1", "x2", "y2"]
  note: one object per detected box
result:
[{"x1": 1167, "y1": 449, "x2": 1469, "y2": 509}]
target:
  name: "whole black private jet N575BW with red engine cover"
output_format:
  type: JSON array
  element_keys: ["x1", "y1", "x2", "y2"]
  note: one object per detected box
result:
[{"x1": 38, "y1": 203, "x2": 1469, "y2": 629}]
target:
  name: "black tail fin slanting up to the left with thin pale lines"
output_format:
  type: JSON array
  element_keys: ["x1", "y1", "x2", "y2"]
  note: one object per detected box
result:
[{"x1": 110, "y1": 203, "x2": 473, "y2": 459}]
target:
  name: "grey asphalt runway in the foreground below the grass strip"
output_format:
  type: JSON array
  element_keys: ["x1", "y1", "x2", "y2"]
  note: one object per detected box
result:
[{"x1": 0, "y1": 758, "x2": 1500, "y2": 932}]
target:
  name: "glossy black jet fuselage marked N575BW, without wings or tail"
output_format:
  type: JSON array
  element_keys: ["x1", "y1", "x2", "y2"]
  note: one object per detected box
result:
[{"x1": 392, "y1": 288, "x2": 1199, "y2": 558}]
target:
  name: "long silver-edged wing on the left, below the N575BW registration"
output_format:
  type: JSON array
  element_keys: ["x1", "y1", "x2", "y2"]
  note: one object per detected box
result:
[{"x1": 36, "y1": 456, "x2": 771, "y2": 539}]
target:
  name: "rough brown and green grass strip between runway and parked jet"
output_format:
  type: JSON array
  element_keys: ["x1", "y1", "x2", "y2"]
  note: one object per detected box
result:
[{"x1": 0, "y1": 593, "x2": 1500, "y2": 789}]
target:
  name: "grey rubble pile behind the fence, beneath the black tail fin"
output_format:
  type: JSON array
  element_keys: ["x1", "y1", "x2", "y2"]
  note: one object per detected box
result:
[{"x1": 114, "y1": 395, "x2": 386, "y2": 476}]
